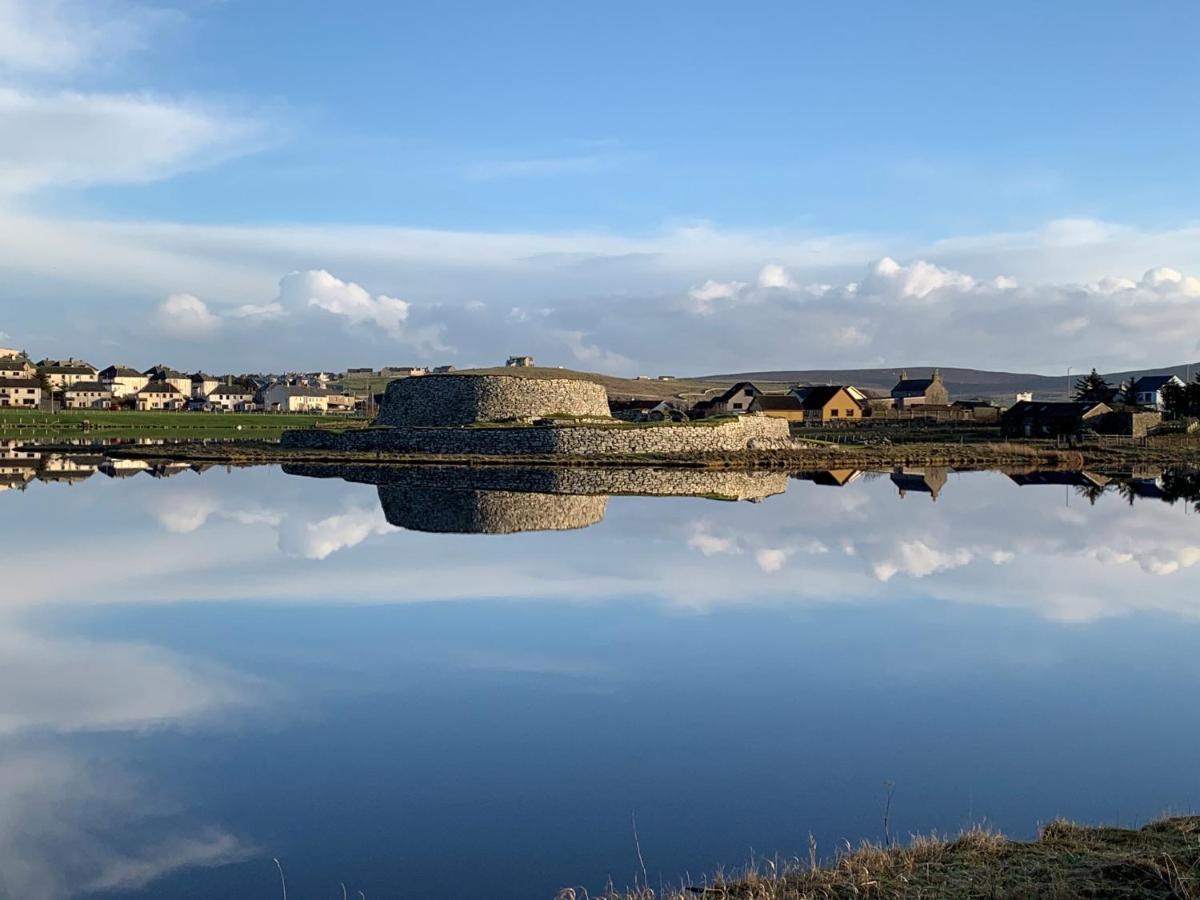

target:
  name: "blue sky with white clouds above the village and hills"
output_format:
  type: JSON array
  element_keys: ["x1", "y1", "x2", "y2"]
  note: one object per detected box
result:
[{"x1": 0, "y1": 0, "x2": 1200, "y2": 374}]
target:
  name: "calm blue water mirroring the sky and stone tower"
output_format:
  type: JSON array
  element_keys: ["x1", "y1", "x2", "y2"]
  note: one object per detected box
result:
[{"x1": 0, "y1": 457, "x2": 1200, "y2": 900}]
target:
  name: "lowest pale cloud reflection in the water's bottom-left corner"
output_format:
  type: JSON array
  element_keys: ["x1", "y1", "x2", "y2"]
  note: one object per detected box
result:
[{"x1": 0, "y1": 746, "x2": 252, "y2": 900}]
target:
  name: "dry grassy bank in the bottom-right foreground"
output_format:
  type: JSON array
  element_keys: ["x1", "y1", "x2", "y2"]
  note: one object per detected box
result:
[{"x1": 588, "y1": 816, "x2": 1200, "y2": 900}]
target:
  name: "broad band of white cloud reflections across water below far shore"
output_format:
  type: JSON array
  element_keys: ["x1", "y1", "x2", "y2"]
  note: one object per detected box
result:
[{"x1": 0, "y1": 468, "x2": 1200, "y2": 620}]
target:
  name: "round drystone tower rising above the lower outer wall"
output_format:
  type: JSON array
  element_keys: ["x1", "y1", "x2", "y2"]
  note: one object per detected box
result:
[{"x1": 376, "y1": 374, "x2": 610, "y2": 427}]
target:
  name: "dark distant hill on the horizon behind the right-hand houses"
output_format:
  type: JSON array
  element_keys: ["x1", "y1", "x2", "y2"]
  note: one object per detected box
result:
[{"x1": 704, "y1": 362, "x2": 1200, "y2": 401}]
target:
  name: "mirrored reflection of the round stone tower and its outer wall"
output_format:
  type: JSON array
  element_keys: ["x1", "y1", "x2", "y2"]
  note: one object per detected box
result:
[{"x1": 276, "y1": 463, "x2": 787, "y2": 534}]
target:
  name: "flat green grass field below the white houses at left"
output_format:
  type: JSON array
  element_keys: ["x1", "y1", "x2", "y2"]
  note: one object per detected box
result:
[{"x1": 0, "y1": 409, "x2": 359, "y2": 440}]
